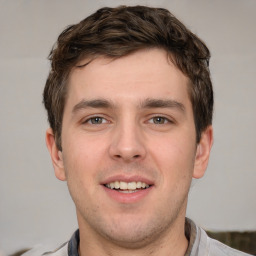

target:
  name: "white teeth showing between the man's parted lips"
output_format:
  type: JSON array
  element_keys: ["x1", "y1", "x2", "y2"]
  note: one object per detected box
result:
[{"x1": 104, "y1": 181, "x2": 151, "y2": 193}]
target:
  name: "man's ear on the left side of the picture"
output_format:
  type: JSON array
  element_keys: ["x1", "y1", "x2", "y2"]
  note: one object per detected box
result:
[{"x1": 45, "y1": 128, "x2": 66, "y2": 181}]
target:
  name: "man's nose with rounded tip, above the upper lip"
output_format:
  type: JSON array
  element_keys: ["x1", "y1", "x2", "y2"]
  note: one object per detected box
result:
[{"x1": 109, "y1": 120, "x2": 146, "y2": 162}]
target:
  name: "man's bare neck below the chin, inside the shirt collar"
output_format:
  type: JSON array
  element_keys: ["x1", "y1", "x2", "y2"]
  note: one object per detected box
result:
[{"x1": 79, "y1": 217, "x2": 188, "y2": 256}]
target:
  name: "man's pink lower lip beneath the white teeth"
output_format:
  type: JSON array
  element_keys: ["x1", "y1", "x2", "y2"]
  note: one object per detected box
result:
[{"x1": 103, "y1": 185, "x2": 153, "y2": 204}]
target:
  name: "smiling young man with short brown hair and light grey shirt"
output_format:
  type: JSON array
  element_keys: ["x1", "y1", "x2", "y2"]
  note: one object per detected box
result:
[{"x1": 24, "y1": 6, "x2": 252, "y2": 256}]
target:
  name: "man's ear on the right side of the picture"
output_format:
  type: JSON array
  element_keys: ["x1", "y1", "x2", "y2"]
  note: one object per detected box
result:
[{"x1": 193, "y1": 125, "x2": 213, "y2": 179}]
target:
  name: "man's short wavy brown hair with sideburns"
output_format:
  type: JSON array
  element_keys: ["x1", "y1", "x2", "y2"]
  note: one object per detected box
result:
[{"x1": 43, "y1": 6, "x2": 213, "y2": 150}]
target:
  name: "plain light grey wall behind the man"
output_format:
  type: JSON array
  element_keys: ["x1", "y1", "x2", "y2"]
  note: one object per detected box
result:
[{"x1": 0, "y1": 0, "x2": 256, "y2": 254}]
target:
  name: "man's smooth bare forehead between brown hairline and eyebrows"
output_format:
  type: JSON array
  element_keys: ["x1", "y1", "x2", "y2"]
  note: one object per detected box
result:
[{"x1": 67, "y1": 49, "x2": 189, "y2": 106}]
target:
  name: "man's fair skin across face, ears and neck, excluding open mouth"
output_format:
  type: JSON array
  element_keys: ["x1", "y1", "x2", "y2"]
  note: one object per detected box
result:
[{"x1": 46, "y1": 49, "x2": 213, "y2": 256}]
